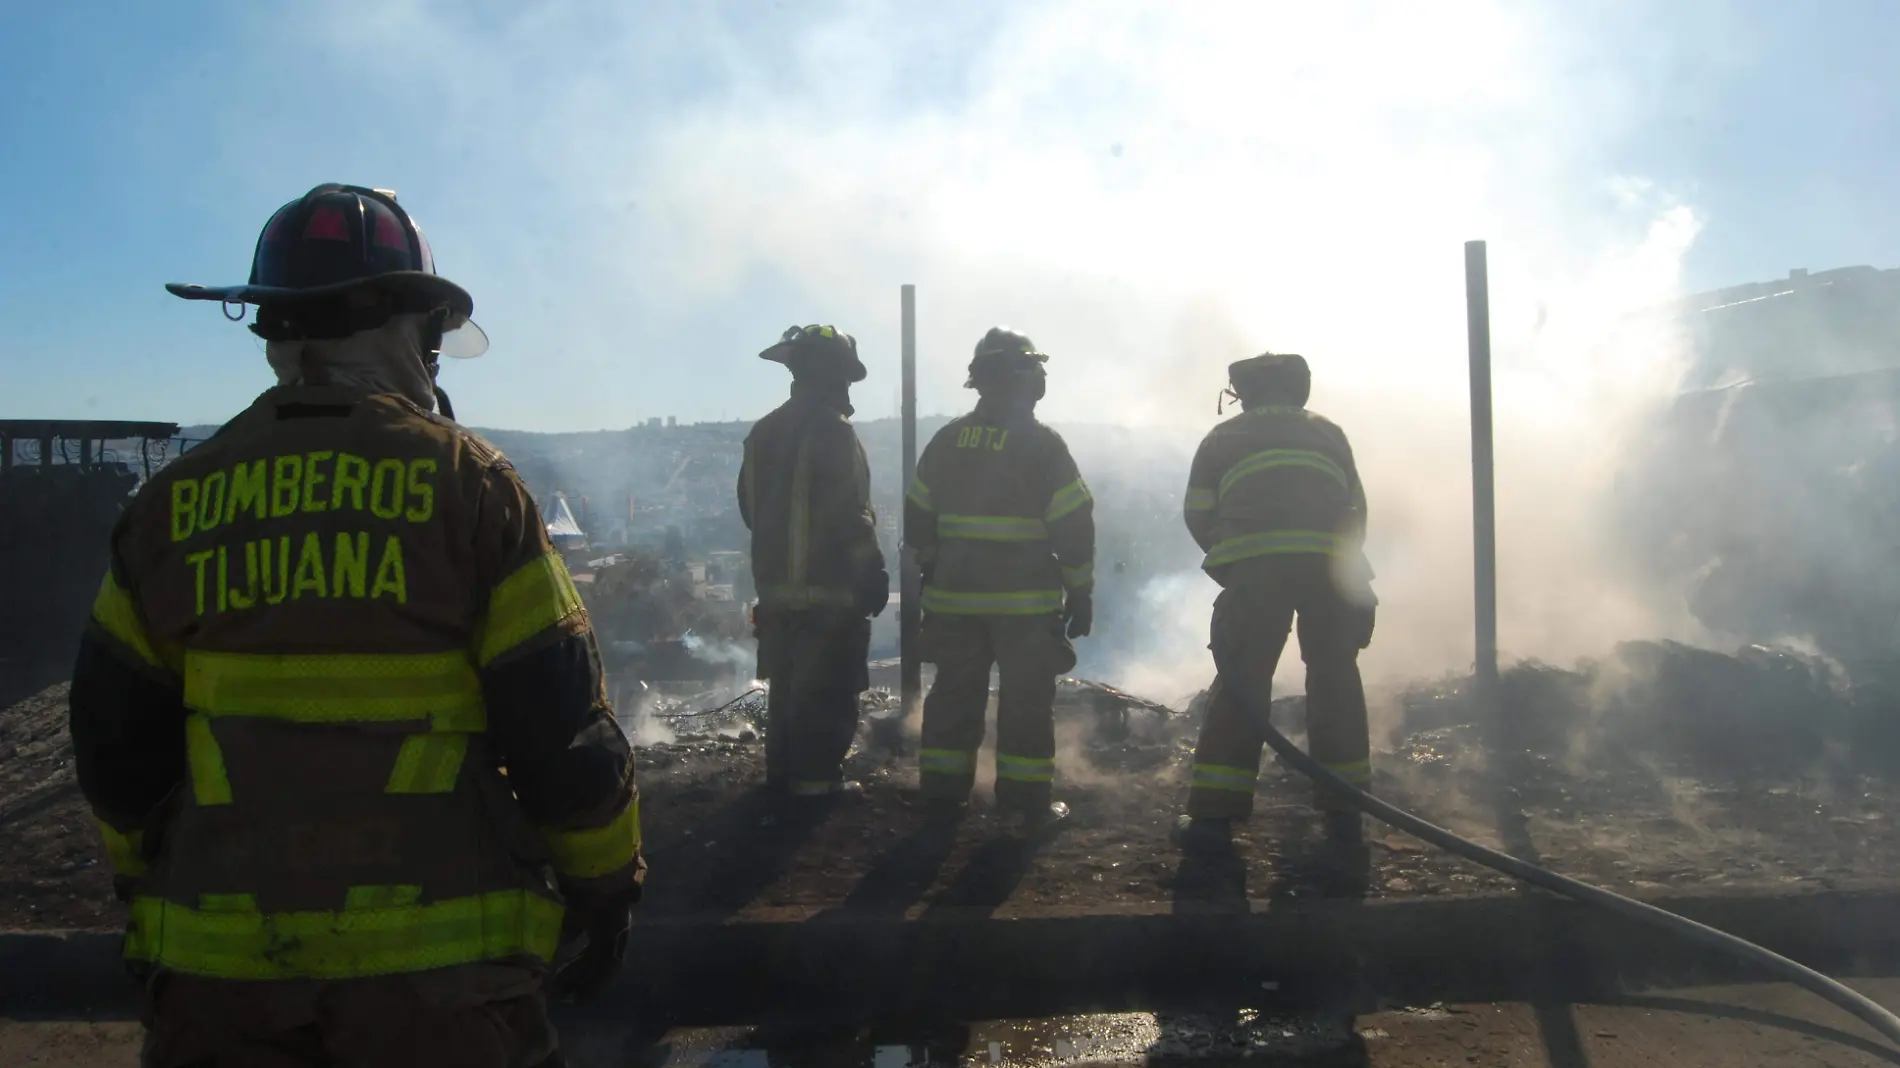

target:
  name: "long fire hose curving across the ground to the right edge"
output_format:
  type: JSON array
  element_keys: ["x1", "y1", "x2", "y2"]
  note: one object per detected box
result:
[{"x1": 1214, "y1": 634, "x2": 1900, "y2": 1045}]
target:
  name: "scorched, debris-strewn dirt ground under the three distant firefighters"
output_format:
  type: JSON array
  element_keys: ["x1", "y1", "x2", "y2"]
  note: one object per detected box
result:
[{"x1": 11, "y1": 634, "x2": 1900, "y2": 929}]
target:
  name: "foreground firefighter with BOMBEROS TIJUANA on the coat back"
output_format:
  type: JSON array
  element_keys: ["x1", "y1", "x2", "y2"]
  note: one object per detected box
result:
[{"x1": 70, "y1": 184, "x2": 644, "y2": 1068}]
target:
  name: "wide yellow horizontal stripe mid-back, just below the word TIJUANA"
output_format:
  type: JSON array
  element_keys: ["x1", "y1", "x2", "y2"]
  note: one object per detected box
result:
[{"x1": 184, "y1": 650, "x2": 488, "y2": 732}]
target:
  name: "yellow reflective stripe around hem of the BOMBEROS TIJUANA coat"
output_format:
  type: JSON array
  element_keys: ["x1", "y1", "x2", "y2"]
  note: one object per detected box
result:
[{"x1": 125, "y1": 889, "x2": 562, "y2": 979}]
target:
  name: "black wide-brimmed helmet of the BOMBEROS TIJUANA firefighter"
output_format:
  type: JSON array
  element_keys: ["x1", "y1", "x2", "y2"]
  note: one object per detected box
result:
[{"x1": 165, "y1": 182, "x2": 488, "y2": 357}]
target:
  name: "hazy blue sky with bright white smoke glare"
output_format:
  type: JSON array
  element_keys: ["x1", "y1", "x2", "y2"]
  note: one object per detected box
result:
[{"x1": 0, "y1": 0, "x2": 1900, "y2": 429}]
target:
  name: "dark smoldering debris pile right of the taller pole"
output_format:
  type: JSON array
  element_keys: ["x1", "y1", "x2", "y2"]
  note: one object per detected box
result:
[{"x1": 1391, "y1": 642, "x2": 1900, "y2": 781}]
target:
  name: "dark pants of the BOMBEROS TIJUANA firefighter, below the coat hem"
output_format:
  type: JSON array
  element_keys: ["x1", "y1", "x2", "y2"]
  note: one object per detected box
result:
[{"x1": 141, "y1": 963, "x2": 566, "y2": 1068}]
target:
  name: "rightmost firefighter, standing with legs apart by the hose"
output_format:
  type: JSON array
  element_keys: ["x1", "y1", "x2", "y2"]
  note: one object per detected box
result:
[{"x1": 1180, "y1": 353, "x2": 1378, "y2": 849}]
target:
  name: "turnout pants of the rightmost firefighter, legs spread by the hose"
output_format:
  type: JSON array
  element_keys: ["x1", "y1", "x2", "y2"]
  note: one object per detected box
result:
[{"x1": 1188, "y1": 555, "x2": 1372, "y2": 819}]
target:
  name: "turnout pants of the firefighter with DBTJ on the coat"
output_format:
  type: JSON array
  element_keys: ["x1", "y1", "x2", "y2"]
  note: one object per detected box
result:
[{"x1": 918, "y1": 612, "x2": 1075, "y2": 811}]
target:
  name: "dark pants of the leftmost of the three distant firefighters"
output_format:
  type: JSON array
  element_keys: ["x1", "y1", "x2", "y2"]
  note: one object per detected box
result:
[{"x1": 758, "y1": 608, "x2": 870, "y2": 794}]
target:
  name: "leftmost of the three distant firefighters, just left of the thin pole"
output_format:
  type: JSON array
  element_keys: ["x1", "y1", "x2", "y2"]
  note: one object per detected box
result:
[{"x1": 739, "y1": 319, "x2": 891, "y2": 796}]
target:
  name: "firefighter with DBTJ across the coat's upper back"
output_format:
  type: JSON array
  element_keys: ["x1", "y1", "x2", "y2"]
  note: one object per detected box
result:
[{"x1": 904, "y1": 327, "x2": 1094, "y2": 829}]
